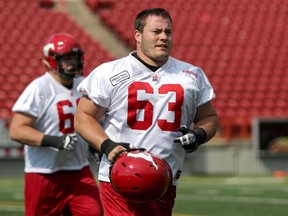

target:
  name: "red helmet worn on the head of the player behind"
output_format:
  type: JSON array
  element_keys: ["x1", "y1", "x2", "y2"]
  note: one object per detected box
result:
[{"x1": 43, "y1": 33, "x2": 83, "y2": 79}]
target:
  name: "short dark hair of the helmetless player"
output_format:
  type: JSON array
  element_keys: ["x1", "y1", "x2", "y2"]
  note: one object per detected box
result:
[{"x1": 134, "y1": 8, "x2": 173, "y2": 33}]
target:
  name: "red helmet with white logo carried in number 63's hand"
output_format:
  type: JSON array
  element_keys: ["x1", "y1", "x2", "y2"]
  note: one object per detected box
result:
[{"x1": 110, "y1": 149, "x2": 172, "y2": 203}]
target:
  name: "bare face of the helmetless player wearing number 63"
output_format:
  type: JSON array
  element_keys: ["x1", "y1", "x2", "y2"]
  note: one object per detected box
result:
[{"x1": 135, "y1": 15, "x2": 173, "y2": 66}]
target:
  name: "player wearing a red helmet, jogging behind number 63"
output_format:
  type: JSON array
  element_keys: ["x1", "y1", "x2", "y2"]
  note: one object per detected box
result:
[{"x1": 10, "y1": 33, "x2": 103, "y2": 216}]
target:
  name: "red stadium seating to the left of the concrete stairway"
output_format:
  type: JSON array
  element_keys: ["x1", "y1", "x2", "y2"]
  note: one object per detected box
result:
[{"x1": 0, "y1": 0, "x2": 115, "y2": 118}]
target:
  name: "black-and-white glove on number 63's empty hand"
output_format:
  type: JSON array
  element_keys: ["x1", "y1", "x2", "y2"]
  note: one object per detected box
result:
[{"x1": 174, "y1": 125, "x2": 199, "y2": 153}]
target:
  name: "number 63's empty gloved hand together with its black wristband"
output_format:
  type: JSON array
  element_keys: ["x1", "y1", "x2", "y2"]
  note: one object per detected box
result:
[{"x1": 174, "y1": 125, "x2": 207, "y2": 153}]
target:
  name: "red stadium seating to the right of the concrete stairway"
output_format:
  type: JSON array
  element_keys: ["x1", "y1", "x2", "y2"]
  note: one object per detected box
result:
[{"x1": 84, "y1": 0, "x2": 288, "y2": 139}]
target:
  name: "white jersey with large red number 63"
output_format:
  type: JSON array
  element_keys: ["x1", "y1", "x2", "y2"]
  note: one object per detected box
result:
[{"x1": 78, "y1": 53, "x2": 215, "y2": 185}]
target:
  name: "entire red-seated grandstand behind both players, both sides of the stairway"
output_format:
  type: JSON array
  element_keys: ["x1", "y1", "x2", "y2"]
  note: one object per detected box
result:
[{"x1": 0, "y1": 0, "x2": 288, "y2": 175}]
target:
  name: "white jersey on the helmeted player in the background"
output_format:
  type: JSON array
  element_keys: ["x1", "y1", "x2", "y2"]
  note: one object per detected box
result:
[{"x1": 12, "y1": 73, "x2": 88, "y2": 173}]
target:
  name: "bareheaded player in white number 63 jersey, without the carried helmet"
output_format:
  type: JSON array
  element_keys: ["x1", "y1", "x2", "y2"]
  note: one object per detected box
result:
[{"x1": 75, "y1": 8, "x2": 218, "y2": 216}]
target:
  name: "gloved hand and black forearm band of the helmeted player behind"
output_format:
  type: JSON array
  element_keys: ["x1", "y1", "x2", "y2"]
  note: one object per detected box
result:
[{"x1": 41, "y1": 134, "x2": 77, "y2": 151}]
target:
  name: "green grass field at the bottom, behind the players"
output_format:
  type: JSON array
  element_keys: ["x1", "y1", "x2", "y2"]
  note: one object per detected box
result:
[{"x1": 0, "y1": 176, "x2": 288, "y2": 216}]
